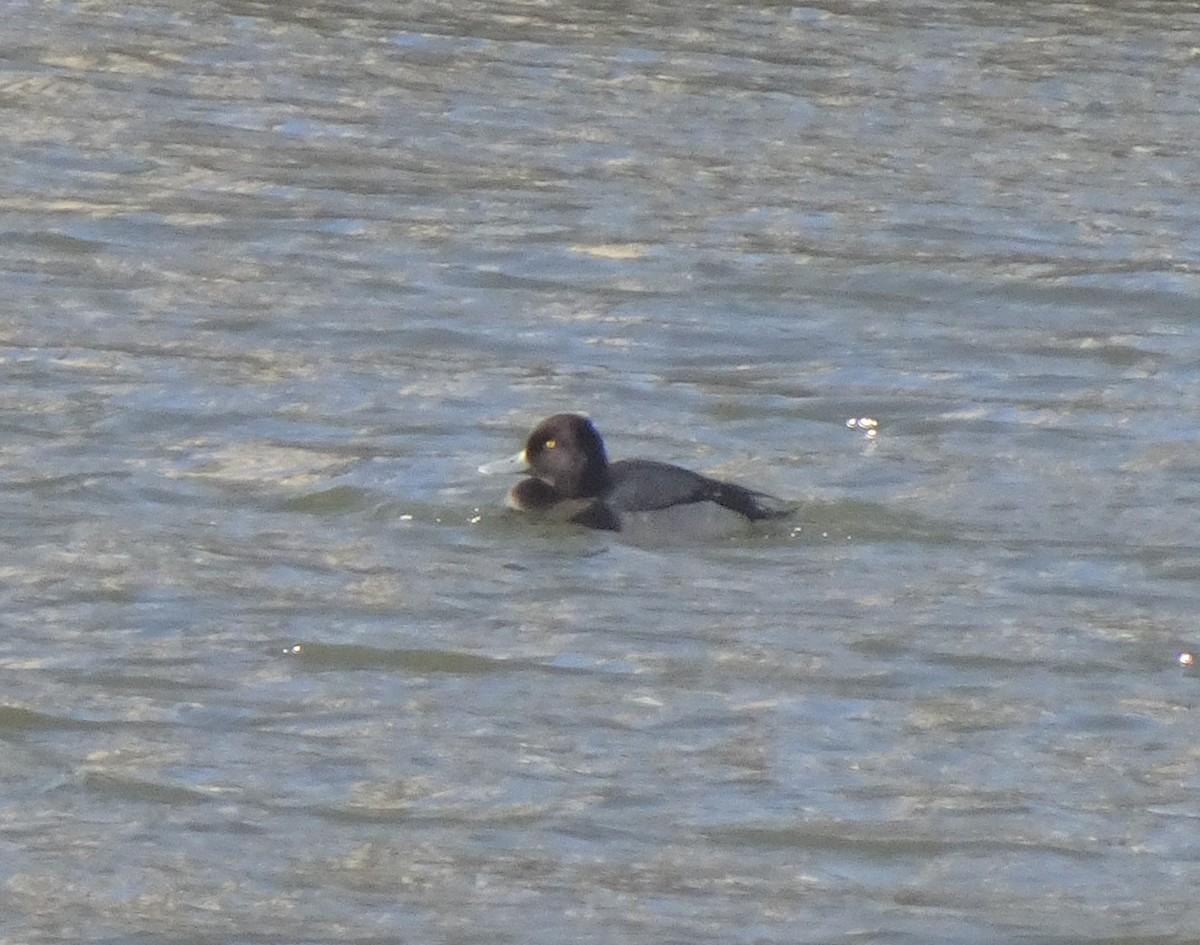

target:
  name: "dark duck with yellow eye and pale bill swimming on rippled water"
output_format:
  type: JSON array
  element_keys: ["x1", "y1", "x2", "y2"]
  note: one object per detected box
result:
[{"x1": 479, "y1": 414, "x2": 792, "y2": 531}]
